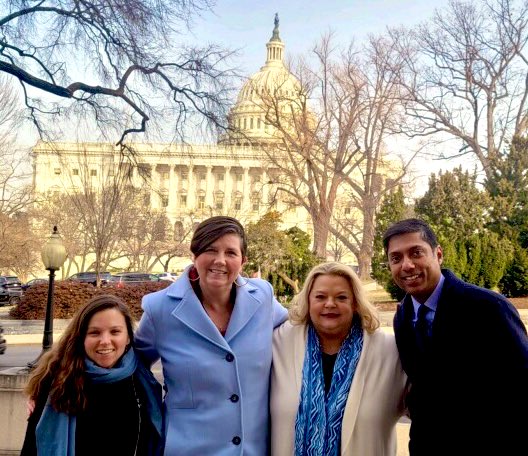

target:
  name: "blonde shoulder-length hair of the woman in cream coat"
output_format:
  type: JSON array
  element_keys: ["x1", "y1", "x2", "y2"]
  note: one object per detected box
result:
[{"x1": 289, "y1": 262, "x2": 380, "y2": 333}]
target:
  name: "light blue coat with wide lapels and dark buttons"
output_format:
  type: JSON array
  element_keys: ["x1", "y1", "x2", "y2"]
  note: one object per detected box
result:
[{"x1": 135, "y1": 271, "x2": 287, "y2": 456}]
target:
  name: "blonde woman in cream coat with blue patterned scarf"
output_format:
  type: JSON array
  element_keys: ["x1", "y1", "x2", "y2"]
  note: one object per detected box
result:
[{"x1": 270, "y1": 263, "x2": 407, "y2": 456}]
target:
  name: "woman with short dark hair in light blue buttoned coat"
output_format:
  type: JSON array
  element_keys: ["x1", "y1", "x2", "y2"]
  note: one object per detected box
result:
[{"x1": 135, "y1": 216, "x2": 287, "y2": 456}]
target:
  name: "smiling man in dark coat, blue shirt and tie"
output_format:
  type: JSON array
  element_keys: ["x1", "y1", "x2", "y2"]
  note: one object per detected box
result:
[{"x1": 383, "y1": 219, "x2": 528, "y2": 456}]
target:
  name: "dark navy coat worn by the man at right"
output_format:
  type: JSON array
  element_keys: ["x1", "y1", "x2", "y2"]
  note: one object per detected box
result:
[{"x1": 394, "y1": 269, "x2": 528, "y2": 456}]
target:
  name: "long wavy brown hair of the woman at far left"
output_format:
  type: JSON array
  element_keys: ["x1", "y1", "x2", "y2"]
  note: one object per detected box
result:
[{"x1": 25, "y1": 295, "x2": 134, "y2": 414}]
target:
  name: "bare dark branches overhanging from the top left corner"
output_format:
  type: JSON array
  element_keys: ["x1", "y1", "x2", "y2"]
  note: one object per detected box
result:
[{"x1": 0, "y1": 0, "x2": 233, "y2": 144}]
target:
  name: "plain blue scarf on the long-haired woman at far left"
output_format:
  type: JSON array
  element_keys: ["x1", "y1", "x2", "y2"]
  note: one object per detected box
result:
[{"x1": 36, "y1": 350, "x2": 155, "y2": 456}]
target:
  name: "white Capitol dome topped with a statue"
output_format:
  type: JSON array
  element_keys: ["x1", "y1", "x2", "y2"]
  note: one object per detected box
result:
[{"x1": 221, "y1": 15, "x2": 301, "y2": 144}]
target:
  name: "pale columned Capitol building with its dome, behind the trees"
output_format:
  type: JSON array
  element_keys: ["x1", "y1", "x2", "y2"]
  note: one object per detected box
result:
[{"x1": 32, "y1": 18, "x2": 322, "y2": 270}]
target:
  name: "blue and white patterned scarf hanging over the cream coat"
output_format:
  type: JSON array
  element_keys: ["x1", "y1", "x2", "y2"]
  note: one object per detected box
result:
[{"x1": 295, "y1": 318, "x2": 363, "y2": 456}]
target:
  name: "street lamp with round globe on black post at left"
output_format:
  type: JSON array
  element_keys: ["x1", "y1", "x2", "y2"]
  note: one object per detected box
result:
[{"x1": 28, "y1": 226, "x2": 66, "y2": 369}]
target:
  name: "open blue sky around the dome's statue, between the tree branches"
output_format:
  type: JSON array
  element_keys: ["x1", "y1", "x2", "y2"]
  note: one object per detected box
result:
[{"x1": 189, "y1": 0, "x2": 448, "y2": 75}]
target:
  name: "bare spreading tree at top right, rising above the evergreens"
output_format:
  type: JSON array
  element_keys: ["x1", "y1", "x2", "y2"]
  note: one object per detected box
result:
[{"x1": 389, "y1": 0, "x2": 528, "y2": 177}]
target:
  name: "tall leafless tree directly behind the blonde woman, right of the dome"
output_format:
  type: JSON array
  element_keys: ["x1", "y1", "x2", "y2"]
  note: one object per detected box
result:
[{"x1": 252, "y1": 34, "x2": 412, "y2": 277}]
